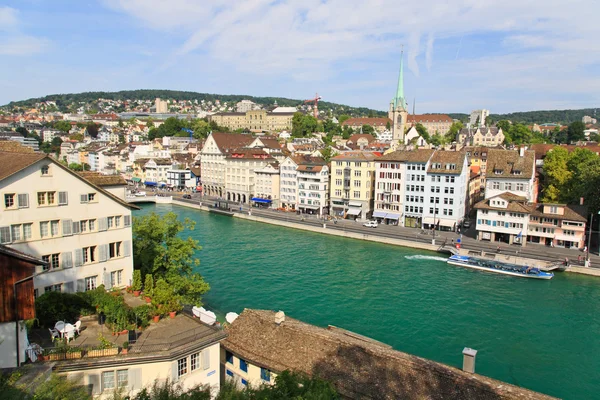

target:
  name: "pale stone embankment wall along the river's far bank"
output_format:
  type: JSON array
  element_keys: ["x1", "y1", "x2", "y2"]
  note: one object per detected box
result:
[{"x1": 172, "y1": 199, "x2": 600, "y2": 277}]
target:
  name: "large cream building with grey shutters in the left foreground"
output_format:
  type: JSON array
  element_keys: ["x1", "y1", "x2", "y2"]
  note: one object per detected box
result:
[{"x1": 0, "y1": 152, "x2": 137, "y2": 295}]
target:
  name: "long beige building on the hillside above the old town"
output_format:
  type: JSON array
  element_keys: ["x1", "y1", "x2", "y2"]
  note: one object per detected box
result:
[{"x1": 208, "y1": 110, "x2": 295, "y2": 132}]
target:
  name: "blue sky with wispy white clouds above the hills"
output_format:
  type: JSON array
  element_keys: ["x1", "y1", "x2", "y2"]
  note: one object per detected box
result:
[{"x1": 0, "y1": 0, "x2": 600, "y2": 114}]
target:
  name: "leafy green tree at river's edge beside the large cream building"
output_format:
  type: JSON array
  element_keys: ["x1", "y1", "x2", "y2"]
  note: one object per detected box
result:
[{"x1": 133, "y1": 212, "x2": 210, "y2": 305}]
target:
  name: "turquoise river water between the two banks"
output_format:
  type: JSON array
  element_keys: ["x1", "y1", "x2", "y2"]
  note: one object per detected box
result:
[{"x1": 134, "y1": 205, "x2": 600, "y2": 399}]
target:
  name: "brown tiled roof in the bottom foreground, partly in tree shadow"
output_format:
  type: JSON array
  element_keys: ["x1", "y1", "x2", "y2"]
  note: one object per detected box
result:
[{"x1": 221, "y1": 309, "x2": 550, "y2": 400}]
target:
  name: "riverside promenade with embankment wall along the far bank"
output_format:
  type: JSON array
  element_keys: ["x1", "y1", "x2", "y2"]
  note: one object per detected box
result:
[{"x1": 173, "y1": 195, "x2": 600, "y2": 277}]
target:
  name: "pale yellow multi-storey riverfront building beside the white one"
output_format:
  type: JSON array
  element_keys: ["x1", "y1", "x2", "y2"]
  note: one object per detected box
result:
[{"x1": 329, "y1": 151, "x2": 379, "y2": 220}]
